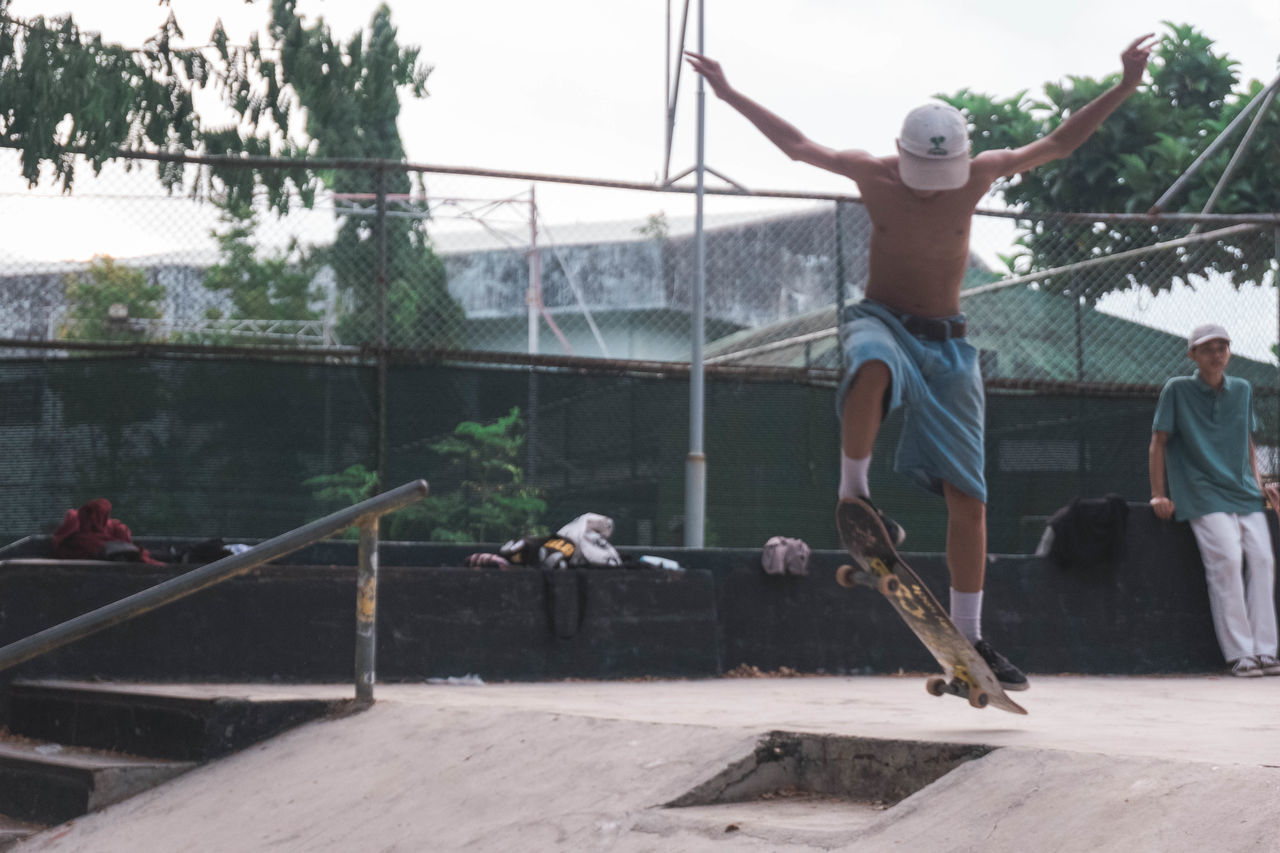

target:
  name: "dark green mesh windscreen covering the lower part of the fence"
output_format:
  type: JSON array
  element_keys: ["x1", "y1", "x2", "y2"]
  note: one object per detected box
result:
[{"x1": 0, "y1": 356, "x2": 1277, "y2": 552}]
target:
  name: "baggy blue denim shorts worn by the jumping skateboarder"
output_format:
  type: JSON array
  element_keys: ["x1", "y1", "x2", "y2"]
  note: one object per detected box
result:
[{"x1": 836, "y1": 301, "x2": 987, "y2": 503}]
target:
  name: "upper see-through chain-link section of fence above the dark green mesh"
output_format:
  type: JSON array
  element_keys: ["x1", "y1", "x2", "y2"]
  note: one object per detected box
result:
[{"x1": 0, "y1": 152, "x2": 1280, "y2": 371}]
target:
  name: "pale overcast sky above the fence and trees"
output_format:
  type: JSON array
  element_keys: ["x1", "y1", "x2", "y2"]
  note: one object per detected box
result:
[{"x1": 0, "y1": 0, "x2": 1280, "y2": 262}]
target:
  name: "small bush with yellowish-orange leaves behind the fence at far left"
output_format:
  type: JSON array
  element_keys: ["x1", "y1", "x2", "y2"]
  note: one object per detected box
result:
[{"x1": 59, "y1": 256, "x2": 165, "y2": 341}]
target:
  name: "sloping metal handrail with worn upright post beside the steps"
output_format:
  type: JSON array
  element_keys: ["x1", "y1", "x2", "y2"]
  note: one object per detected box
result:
[{"x1": 0, "y1": 480, "x2": 428, "y2": 702}]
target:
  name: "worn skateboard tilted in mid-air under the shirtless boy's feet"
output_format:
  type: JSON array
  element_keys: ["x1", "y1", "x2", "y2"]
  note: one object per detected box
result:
[{"x1": 836, "y1": 500, "x2": 1027, "y2": 713}]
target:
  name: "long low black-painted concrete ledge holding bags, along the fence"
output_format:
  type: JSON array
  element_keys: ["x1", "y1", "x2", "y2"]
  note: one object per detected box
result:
[{"x1": 0, "y1": 505, "x2": 1275, "y2": 681}]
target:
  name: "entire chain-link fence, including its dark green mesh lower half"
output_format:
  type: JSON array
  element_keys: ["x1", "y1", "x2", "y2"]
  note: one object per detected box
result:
[{"x1": 0, "y1": 152, "x2": 1280, "y2": 551}]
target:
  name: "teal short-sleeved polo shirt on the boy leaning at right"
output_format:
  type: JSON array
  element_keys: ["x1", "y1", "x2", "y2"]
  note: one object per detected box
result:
[{"x1": 1151, "y1": 370, "x2": 1262, "y2": 521}]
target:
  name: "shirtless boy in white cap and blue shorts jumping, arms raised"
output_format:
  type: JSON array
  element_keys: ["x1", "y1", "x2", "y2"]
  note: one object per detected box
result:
[{"x1": 687, "y1": 33, "x2": 1155, "y2": 690}]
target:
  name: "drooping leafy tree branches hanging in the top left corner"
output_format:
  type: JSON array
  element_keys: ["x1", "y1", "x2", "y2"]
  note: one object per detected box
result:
[{"x1": 0, "y1": 0, "x2": 315, "y2": 210}]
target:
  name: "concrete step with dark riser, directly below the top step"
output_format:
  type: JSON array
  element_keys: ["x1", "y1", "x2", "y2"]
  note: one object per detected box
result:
[{"x1": 0, "y1": 736, "x2": 196, "y2": 824}]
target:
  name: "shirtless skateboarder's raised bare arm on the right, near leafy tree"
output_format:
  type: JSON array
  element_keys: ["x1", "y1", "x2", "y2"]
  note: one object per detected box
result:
[{"x1": 973, "y1": 32, "x2": 1156, "y2": 181}]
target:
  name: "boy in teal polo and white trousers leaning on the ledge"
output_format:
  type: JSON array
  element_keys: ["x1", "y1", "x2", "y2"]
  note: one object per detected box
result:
[{"x1": 1148, "y1": 323, "x2": 1280, "y2": 678}]
